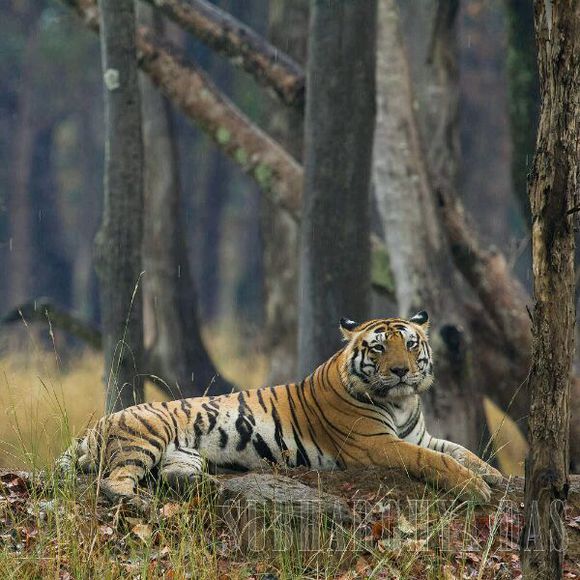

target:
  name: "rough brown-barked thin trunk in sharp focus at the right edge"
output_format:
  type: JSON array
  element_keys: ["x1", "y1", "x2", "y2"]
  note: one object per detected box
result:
[{"x1": 521, "y1": 0, "x2": 580, "y2": 578}]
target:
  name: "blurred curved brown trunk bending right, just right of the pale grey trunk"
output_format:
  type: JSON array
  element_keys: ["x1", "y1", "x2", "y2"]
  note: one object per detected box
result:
[{"x1": 404, "y1": 0, "x2": 530, "y2": 372}]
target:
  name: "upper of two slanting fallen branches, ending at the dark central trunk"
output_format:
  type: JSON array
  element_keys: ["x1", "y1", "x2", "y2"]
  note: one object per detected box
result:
[{"x1": 144, "y1": 0, "x2": 305, "y2": 109}]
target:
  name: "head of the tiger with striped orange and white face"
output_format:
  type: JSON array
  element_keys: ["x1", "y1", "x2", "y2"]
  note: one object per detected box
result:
[{"x1": 340, "y1": 310, "x2": 433, "y2": 403}]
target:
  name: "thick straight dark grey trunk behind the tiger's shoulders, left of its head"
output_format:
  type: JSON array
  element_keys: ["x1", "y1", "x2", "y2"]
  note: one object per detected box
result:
[{"x1": 298, "y1": 0, "x2": 377, "y2": 376}]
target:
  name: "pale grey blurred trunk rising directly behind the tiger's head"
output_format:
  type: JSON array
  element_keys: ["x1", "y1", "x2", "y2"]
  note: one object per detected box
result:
[{"x1": 374, "y1": 0, "x2": 484, "y2": 449}]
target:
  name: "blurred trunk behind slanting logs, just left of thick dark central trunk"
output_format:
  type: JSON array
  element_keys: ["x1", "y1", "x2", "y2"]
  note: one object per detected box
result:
[{"x1": 261, "y1": 0, "x2": 308, "y2": 383}]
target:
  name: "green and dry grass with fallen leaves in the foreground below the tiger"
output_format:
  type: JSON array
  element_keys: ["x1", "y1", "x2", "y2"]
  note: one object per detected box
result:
[{"x1": 0, "y1": 464, "x2": 520, "y2": 579}]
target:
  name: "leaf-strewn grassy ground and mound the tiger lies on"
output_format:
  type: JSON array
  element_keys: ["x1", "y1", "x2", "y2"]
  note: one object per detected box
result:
[{"x1": 0, "y1": 468, "x2": 580, "y2": 580}]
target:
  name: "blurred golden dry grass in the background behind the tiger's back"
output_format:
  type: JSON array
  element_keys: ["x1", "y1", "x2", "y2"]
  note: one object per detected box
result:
[{"x1": 0, "y1": 328, "x2": 267, "y2": 469}]
